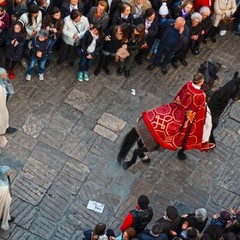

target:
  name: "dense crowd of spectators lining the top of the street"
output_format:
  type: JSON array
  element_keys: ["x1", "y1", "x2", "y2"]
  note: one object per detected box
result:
[{"x1": 0, "y1": 0, "x2": 240, "y2": 81}]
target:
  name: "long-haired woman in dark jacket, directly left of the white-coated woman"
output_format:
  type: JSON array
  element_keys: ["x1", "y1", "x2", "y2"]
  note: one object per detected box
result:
[{"x1": 42, "y1": 7, "x2": 64, "y2": 65}]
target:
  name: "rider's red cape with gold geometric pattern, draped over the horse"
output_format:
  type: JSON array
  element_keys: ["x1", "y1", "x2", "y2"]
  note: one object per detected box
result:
[{"x1": 142, "y1": 82, "x2": 207, "y2": 150}]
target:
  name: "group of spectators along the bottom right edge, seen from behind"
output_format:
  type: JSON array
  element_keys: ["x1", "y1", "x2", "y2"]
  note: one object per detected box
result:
[{"x1": 83, "y1": 195, "x2": 240, "y2": 240}]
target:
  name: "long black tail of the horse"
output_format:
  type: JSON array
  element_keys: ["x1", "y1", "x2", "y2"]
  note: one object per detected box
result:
[{"x1": 117, "y1": 128, "x2": 139, "y2": 163}]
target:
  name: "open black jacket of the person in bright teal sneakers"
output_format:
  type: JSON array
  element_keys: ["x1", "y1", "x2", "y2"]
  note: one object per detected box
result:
[{"x1": 80, "y1": 30, "x2": 104, "y2": 57}]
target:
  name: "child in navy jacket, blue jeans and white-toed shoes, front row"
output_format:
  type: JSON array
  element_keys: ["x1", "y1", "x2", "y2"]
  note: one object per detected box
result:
[{"x1": 26, "y1": 29, "x2": 52, "y2": 81}]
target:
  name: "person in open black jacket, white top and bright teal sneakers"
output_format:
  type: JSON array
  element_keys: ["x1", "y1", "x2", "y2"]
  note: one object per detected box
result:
[{"x1": 78, "y1": 25, "x2": 104, "y2": 82}]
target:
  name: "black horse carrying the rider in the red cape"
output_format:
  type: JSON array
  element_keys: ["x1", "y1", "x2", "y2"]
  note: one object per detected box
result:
[{"x1": 117, "y1": 68, "x2": 240, "y2": 170}]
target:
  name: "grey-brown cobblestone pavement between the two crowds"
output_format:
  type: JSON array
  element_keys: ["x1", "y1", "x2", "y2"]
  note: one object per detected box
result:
[{"x1": 0, "y1": 33, "x2": 240, "y2": 240}]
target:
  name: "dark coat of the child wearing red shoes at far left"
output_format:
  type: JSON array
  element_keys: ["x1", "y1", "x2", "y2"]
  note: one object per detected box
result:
[{"x1": 5, "y1": 29, "x2": 26, "y2": 61}]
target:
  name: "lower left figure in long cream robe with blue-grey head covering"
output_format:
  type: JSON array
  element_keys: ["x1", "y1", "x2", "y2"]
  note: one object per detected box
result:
[{"x1": 0, "y1": 165, "x2": 15, "y2": 231}]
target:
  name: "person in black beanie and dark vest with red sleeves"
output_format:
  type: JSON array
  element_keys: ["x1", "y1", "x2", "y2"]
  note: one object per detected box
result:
[{"x1": 120, "y1": 195, "x2": 153, "y2": 233}]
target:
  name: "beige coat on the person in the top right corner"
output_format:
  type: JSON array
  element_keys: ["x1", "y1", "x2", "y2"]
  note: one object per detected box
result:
[{"x1": 213, "y1": 0, "x2": 237, "y2": 27}]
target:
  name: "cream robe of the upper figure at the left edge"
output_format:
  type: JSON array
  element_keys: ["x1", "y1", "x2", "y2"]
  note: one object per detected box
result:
[{"x1": 0, "y1": 84, "x2": 9, "y2": 135}]
